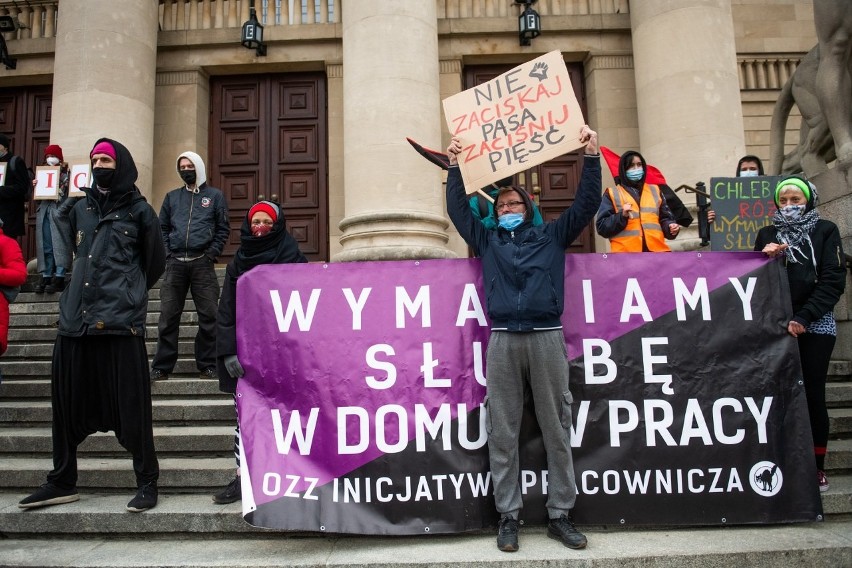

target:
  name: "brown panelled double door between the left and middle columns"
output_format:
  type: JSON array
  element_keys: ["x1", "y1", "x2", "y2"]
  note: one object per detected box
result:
[{"x1": 208, "y1": 73, "x2": 329, "y2": 262}]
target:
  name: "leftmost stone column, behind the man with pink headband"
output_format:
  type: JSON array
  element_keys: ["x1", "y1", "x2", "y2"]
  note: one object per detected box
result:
[{"x1": 50, "y1": 0, "x2": 159, "y2": 197}]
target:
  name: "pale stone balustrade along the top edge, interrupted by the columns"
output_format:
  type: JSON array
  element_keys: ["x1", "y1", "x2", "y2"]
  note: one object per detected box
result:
[{"x1": 0, "y1": 0, "x2": 629, "y2": 39}]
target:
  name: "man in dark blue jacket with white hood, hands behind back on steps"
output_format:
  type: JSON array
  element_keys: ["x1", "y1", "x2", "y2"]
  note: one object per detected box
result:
[{"x1": 151, "y1": 152, "x2": 230, "y2": 380}]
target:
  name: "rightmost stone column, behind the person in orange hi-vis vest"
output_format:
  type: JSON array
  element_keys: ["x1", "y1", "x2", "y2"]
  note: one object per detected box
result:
[{"x1": 630, "y1": 0, "x2": 745, "y2": 248}]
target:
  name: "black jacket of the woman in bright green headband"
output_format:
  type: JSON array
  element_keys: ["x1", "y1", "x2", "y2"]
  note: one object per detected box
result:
[{"x1": 754, "y1": 219, "x2": 846, "y2": 327}]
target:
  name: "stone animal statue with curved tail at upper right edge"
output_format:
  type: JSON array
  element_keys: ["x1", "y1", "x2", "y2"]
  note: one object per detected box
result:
[{"x1": 769, "y1": 0, "x2": 852, "y2": 177}]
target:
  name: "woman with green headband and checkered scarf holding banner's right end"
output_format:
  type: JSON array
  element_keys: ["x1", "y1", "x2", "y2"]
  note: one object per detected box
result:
[{"x1": 754, "y1": 176, "x2": 846, "y2": 491}]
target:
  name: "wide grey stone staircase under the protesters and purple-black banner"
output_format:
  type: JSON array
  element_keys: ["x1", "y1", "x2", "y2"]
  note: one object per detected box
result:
[{"x1": 0, "y1": 269, "x2": 852, "y2": 568}]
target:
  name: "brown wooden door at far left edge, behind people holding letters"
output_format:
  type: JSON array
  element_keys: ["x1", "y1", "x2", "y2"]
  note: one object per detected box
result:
[{"x1": 0, "y1": 85, "x2": 52, "y2": 260}]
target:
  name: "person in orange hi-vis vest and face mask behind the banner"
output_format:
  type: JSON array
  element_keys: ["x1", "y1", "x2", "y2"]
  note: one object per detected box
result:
[{"x1": 595, "y1": 151, "x2": 680, "y2": 252}]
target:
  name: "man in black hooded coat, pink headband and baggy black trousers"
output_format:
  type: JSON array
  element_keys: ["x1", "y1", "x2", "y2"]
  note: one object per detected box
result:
[{"x1": 19, "y1": 138, "x2": 165, "y2": 512}]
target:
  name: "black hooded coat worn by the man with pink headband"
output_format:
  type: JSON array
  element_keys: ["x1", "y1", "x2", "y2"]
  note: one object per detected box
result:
[{"x1": 59, "y1": 138, "x2": 166, "y2": 337}]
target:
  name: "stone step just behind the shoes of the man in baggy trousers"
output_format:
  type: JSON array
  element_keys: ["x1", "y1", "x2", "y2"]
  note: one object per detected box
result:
[{"x1": 0, "y1": 458, "x2": 236, "y2": 492}]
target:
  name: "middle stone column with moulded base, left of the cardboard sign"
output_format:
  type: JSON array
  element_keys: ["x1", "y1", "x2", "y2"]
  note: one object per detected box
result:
[{"x1": 334, "y1": 0, "x2": 454, "y2": 261}]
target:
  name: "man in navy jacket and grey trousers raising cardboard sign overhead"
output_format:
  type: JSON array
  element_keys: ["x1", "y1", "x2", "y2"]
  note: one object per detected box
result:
[{"x1": 447, "y1": 126, "x2": 601, "y2": 552}]
